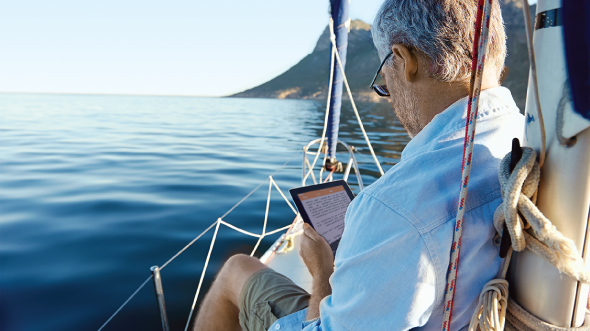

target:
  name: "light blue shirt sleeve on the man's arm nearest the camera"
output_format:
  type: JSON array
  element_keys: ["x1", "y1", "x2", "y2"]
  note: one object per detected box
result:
[{"x1": 304, "y1": 194, "x2": 436, "y2": 331}]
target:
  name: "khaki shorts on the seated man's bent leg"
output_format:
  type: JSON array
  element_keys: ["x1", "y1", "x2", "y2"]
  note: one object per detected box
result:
[{"x1": 239, "y1": 268, "x2": 309, "y2": 331}]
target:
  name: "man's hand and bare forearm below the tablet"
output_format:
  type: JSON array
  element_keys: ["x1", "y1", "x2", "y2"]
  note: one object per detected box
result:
[{"x1": 299, "y1": 223, "x2": 334, "y2": 320}]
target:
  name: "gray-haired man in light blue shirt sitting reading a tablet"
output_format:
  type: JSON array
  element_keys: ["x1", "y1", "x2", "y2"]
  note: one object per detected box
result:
[{"x1": 195, "y1": 0, "x2": 524, "y2": 331}]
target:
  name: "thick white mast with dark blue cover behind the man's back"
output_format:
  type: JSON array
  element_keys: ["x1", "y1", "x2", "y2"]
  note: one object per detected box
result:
[{"x1": 508, "y1": 0, "x2": 590, "y2": 328}]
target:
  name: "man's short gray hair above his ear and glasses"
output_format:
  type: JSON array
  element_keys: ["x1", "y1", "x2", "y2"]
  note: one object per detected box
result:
[{"x1": 371, "y1": 0, "x2": 506, "y2": 82}]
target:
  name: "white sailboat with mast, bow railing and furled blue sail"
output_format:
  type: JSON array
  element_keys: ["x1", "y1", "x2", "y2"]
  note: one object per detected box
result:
[{"x1": 95, "y1": 0, "x2": 590, "y2": 330}]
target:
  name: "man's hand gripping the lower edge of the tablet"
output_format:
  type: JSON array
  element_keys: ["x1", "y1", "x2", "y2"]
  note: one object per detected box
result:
[{"x1": 299, "y1": 223, "x2": 334, "y2": 279}]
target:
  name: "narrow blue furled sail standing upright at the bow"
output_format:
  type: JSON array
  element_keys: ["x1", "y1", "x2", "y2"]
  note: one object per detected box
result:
[{"x1": 326, "y1": 0, "x2": 350, "y2": 170}]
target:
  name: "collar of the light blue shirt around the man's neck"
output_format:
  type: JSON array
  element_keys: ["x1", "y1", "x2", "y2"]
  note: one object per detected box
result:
[{"x1": 401, "y1": 86, "x2": 518, "y2": 160}]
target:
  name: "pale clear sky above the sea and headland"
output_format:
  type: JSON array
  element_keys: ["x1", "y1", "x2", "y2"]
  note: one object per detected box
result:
[{"x1": 0, "y1": 0, "x2": 382, "y2": 96}]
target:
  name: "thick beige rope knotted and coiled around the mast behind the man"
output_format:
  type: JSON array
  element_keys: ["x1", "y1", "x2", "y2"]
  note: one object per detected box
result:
[{"x1": 469, "y1": 0, "x2": 576, "y2": 331}]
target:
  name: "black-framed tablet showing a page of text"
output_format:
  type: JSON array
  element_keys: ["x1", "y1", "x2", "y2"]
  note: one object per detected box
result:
[{"x1": 289, "y1": 180, "x2": 354, "y2": 254}]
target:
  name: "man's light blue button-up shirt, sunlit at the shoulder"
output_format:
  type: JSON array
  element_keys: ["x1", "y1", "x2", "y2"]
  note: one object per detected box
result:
[{"x1": 270, "y1": 87, "x2": 524, "y2": 331}]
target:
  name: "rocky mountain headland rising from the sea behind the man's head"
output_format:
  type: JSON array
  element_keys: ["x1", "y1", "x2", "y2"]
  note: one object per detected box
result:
[{"x1": 231, "y1": 0, "x2": 535, "y2": 111}]
